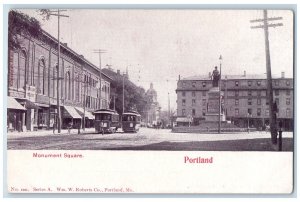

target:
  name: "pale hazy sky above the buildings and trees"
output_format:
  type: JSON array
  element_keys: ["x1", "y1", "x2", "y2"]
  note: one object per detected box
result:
[{"x1": 17, "y1": 9, "x2": 293, "y2": 110}]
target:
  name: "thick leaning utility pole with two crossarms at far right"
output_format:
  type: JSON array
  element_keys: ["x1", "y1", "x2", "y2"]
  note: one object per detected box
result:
[{"x1": 250, "y1": 10, "x2": 283, "y2": 144}]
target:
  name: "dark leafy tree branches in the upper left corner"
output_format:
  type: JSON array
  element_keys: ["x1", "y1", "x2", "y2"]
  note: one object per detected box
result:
[{"x1": 8, "y1": 10, "x2": 42, "y2": 50}]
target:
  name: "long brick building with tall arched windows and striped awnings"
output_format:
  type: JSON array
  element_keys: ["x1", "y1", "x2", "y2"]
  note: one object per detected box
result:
[{"x1": 7, "y1": 21, "x2": 111, "y2": 131}]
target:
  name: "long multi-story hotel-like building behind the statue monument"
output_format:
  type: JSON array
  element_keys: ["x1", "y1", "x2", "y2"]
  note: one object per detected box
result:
[{"x1": 176, "y1": 72, "x2": 293, "y2": 129}]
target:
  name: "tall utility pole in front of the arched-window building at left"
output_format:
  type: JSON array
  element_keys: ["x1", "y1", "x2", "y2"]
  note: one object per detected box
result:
[{"x1": 47, "y1": 9, "x2": 69, "y2": 133}]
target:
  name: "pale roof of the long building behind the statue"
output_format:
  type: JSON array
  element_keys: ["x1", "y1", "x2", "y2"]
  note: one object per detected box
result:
[{"x1": 181, "y1": 74, "x2": 289, "y2": 80}]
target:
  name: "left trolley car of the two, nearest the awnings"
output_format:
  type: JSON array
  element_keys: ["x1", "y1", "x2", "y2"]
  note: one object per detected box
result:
[{"x1": 93, "y1": 109, "x2": 120, "y2": 134}]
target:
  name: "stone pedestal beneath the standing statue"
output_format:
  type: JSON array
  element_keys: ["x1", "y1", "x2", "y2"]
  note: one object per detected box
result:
[{"x1": 205, "y1": 87, "x2": 225, "y2": 122}]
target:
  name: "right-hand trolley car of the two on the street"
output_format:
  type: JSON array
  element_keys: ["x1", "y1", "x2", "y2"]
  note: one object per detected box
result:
[{"x1": 122, "y1": 111, "x2": 141, "y2": 132}]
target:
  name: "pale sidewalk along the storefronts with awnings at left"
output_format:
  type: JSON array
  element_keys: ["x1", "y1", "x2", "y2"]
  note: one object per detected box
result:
[{"x1": 7, "y1": 128, "x2": 95, "y2": 138}]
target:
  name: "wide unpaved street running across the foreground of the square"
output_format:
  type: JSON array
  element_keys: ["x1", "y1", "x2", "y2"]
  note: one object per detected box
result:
[{"x1": 7, "y1": 128, "x2": 293, "y2": 151}]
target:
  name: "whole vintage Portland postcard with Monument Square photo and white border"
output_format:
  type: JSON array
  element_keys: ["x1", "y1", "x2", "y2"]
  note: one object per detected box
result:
[{"x1": 4, "y1": 8, "x2": 295, "y2": 194}]
